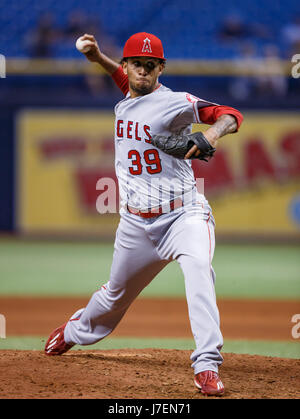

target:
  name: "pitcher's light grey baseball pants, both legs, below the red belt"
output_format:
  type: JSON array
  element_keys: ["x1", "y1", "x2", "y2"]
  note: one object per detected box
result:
[{"x1": 65, "y1": 204, "x2": 223, "y2": 374}]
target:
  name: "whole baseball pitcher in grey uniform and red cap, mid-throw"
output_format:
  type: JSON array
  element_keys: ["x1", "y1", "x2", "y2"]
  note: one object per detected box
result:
[{"x1": 45, "y1": 32, "x2": 243, "y2": 395}]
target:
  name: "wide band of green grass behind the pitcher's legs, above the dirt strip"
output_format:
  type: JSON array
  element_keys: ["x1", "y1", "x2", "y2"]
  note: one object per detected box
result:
[{"x1": 0, "y1": 239, "x2": 300, "y2": 299}]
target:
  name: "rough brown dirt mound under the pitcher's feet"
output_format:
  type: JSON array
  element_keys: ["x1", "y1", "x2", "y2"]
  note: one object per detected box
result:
[{"x1": 0, "y1": 349, "x2": 300, "y2": 399}]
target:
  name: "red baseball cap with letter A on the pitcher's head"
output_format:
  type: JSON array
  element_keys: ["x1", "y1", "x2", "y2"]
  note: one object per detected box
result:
[{"x1": 123, "y1": 32, "x2": 165, "y2": 60}]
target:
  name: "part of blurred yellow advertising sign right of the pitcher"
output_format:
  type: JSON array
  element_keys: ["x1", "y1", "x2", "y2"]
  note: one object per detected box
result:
[{"x1": 193, "y1": 111, "x2": 300, "y2": 238}]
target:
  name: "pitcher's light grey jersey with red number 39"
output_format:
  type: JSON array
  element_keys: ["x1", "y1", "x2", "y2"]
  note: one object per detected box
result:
[{"x1": 115, "y1": 85, "x2": 214, "y2": 210}]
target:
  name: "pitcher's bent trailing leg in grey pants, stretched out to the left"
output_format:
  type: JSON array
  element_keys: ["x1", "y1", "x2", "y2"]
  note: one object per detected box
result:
[{"x1": 65, "y1": 215, "x2": 166, "y2": 345}]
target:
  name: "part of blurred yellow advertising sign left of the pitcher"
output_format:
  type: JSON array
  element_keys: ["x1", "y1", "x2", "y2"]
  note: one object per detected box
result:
[{"x1": 16, "y1": 110, "x2": 119, "y2": 237}]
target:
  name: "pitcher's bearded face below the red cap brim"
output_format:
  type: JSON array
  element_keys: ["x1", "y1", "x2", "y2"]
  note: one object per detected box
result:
[{"x1": 123, "y1": 57, "x2": 164, "y2": 97}]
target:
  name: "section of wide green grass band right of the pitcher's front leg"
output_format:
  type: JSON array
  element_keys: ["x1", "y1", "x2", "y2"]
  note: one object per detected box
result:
[{"x1": 214, "y1": 245, "x2": 300, "y2": 299}]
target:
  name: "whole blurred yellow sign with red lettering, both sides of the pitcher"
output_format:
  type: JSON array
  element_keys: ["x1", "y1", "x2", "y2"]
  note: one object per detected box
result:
[{"x1": 16, "y1": 110, "x2": 300, "y2": 237}]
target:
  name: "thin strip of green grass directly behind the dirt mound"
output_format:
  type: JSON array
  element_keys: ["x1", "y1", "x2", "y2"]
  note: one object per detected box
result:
[{"x1": 0, "y1": 336, "x2": 300, "y2": 359}]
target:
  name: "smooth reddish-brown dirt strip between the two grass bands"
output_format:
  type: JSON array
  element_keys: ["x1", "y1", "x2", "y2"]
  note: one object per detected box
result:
[{"x1": 0, "y1": 297, "x2": 300, "y2": 341}]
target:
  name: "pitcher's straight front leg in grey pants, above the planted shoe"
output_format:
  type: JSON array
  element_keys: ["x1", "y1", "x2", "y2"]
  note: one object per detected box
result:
[{"x1": 166, "y1": 209, "x2": 223, "y2": 374}]
